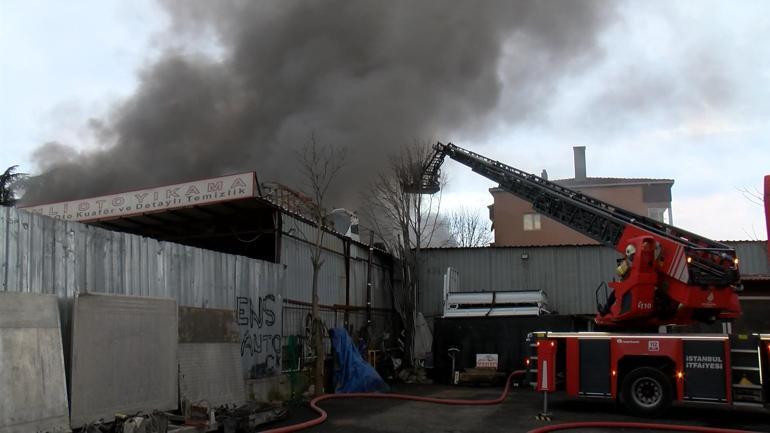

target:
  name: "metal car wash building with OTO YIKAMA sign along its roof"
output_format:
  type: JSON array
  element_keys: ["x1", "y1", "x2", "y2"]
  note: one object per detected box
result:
[{"x1": 13, "y1": 172, "x2": 393, "y2": 335}]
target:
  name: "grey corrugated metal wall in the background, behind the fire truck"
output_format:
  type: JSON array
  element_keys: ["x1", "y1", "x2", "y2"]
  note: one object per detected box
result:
[{"x1": 419, "y1": 241, "x2": 770, "y2": 318}]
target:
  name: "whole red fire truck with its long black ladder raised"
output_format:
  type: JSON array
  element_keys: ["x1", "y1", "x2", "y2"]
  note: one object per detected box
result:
[{"x1": 409, "y1": 143, "x2": 770, "y2": 416}]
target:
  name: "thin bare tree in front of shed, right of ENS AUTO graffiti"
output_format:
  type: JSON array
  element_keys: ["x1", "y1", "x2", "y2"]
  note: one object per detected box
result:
[{"x1": 298, "y1": 135, "x2": 346, "y2": 395}]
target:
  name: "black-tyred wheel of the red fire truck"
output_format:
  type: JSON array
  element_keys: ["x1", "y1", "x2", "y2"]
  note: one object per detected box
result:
[{"x1": 621, "y1": 367, "x2": 672, "y2": 416}]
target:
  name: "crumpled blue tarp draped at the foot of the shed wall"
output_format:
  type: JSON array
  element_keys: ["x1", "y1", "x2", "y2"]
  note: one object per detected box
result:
[{"x1": 332, "y1": 328, "x2": 390, "y2": 393}]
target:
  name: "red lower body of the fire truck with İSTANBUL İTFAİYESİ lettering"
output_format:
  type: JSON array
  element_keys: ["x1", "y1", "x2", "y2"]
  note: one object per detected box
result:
[{"x1": 532, "y1": 332, "x2": 770, "y2": 416}]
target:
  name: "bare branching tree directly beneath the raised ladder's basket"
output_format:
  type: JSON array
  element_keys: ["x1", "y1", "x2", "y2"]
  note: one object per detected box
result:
[{"x1": 364, "y1": 143, "x2": 441, "y2": 363}]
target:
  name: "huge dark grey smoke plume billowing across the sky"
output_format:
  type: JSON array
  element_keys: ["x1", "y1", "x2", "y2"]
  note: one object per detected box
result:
[{"x1": 24, "y1": 0, "x2": 608, "y2": 205}]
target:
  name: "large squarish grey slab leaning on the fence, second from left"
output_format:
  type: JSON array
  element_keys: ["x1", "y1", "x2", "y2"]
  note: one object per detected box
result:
[{"x1": 71, "y1": 294, "x2": 178, "y2": 427}]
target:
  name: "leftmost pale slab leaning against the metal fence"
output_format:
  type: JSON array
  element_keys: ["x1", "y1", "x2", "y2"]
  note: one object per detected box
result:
[{"x1": 0, "y1": 292, "x2": 69, "y2": 433}]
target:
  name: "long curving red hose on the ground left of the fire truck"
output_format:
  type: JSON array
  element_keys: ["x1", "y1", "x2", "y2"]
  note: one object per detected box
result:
[{"x1": 262, "y1": 370, "x2": 525, "y2": 433}]
